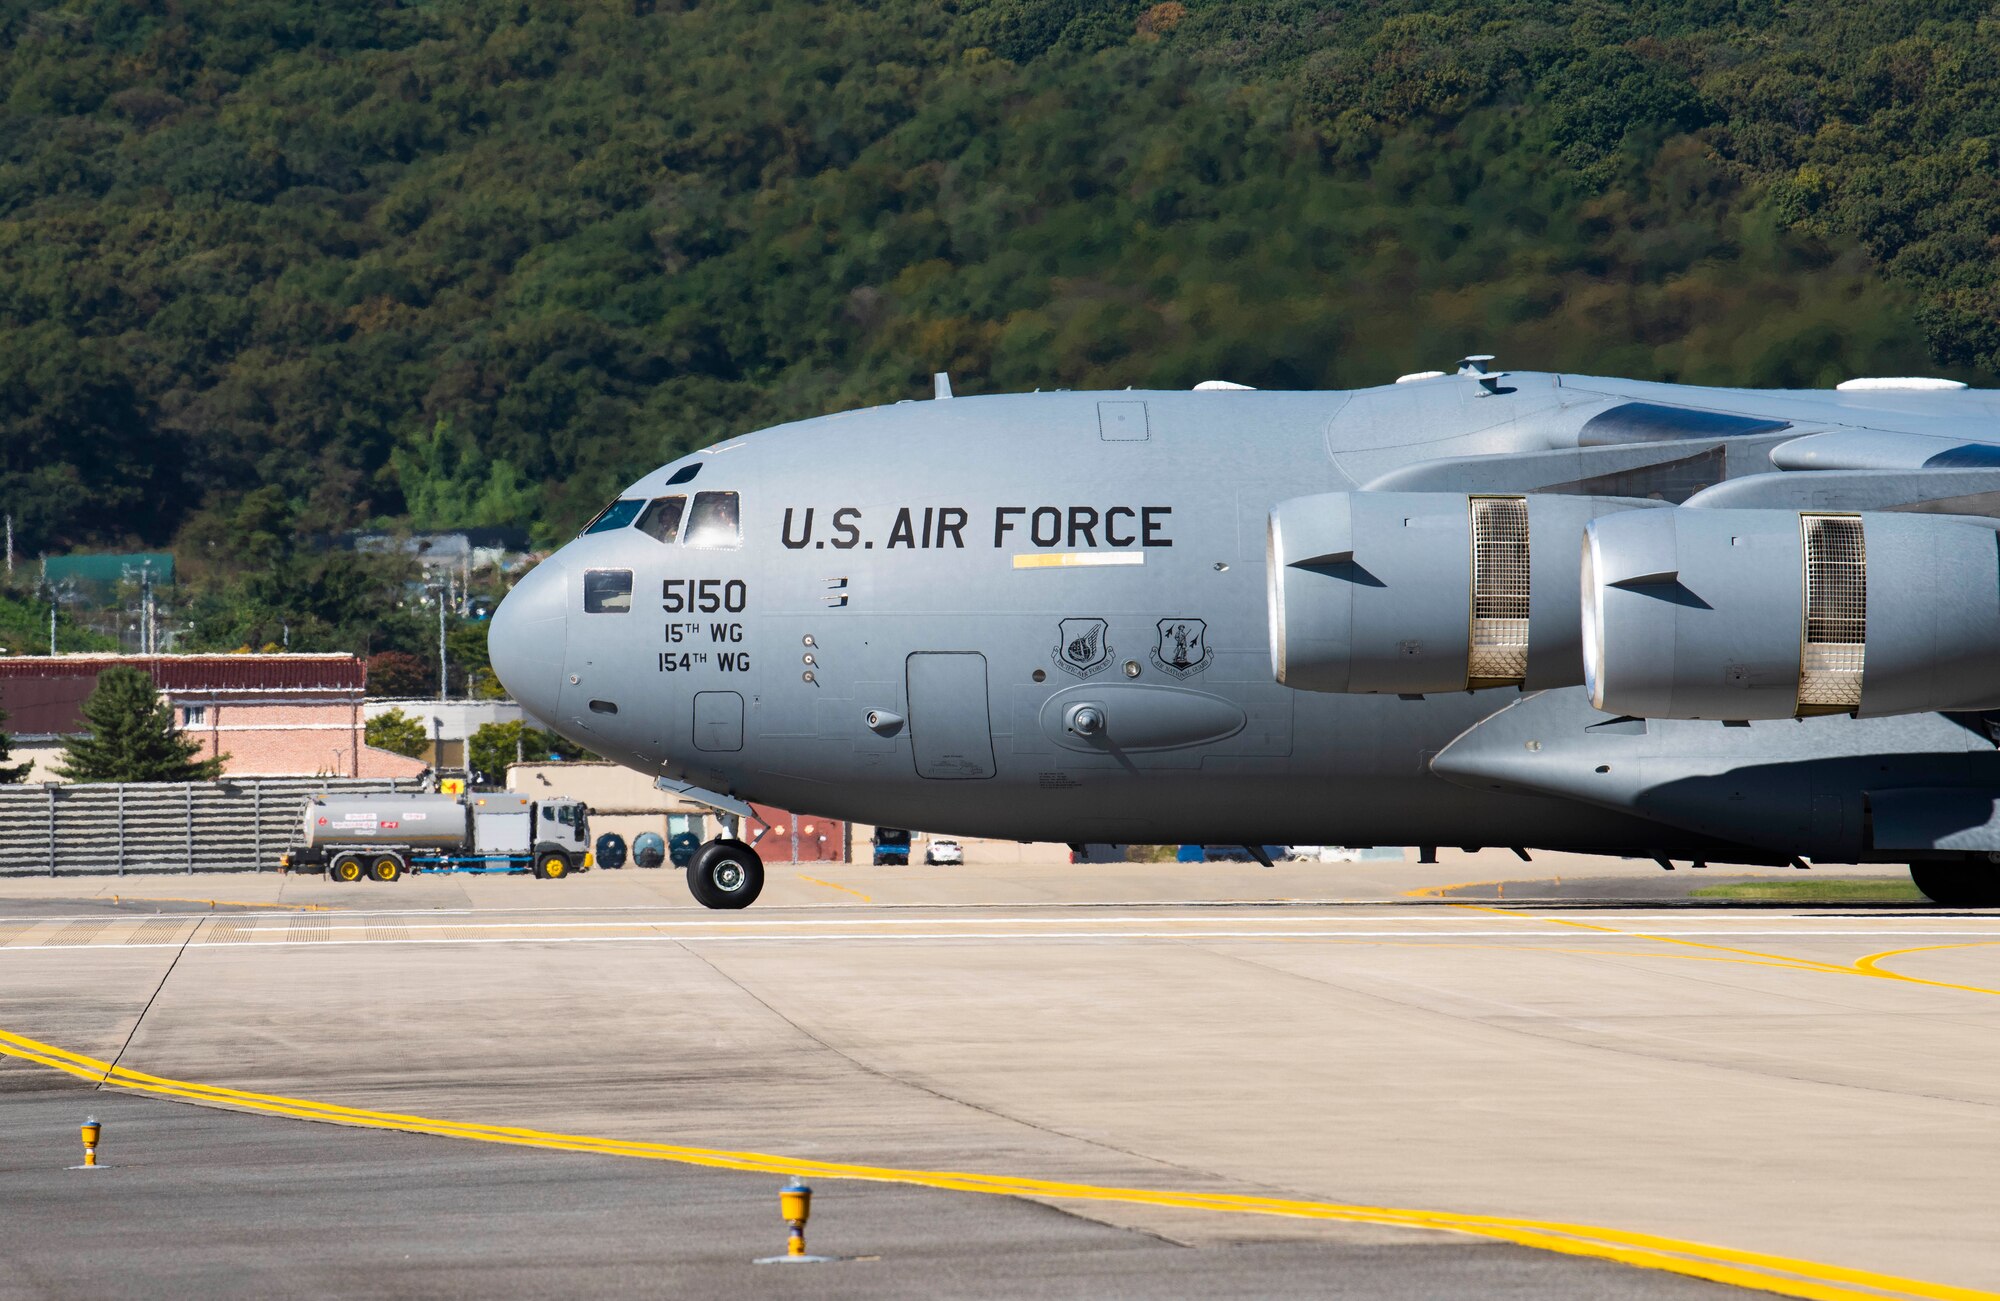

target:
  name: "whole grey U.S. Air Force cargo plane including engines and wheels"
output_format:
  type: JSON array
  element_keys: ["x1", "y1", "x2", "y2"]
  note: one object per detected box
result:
[{"x1": 492, "y1": 356, "x2": 2000, "y2": 907}]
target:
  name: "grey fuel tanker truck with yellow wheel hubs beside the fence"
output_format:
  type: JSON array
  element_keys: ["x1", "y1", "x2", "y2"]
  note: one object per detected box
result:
[{"x1": 280, "y1": 793, "x2": 590, "y2": 881}]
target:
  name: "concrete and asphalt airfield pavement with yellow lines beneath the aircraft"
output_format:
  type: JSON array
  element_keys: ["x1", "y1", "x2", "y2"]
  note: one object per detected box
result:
[{"x1": 0, "y1": 853, "x2": 2000, "y2": 1299}]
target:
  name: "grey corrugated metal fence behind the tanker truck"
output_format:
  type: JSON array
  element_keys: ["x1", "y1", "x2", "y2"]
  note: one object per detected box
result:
[{"x1": 0, "y1": 777, "x2": 420, "y2": 877}]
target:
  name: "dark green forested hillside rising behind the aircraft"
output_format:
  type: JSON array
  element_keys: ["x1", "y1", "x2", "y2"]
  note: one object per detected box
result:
[{"x1": 0, "y1": 0, "x2": 2000, "y2": 628}]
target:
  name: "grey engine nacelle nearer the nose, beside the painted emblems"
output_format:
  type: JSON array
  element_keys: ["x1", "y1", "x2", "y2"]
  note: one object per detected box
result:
[{"x1": 1268, "y1": 492, "x2": 1664, "y2": 695}]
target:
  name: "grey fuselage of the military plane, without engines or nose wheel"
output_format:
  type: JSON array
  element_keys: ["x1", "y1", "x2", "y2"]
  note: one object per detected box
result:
[{"x1": 492, "y1": 372, "x2": 1994, "y2": 861}]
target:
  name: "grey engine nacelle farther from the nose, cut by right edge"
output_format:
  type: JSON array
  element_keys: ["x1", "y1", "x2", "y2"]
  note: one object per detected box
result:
[{"x1": 1584, "y1": 510, "x2": 2000, "y2": 719}]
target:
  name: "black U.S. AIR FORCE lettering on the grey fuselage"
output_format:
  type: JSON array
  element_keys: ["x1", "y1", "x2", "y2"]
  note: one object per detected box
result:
[{"x1": 782, "y1": 506, "x2": 1174, "y2": 550}]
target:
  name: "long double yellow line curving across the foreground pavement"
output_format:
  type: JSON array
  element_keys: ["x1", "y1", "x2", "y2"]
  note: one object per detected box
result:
[{"x1": 0, "y1": 1031, "x2": 1976, "y2": 1301}]
